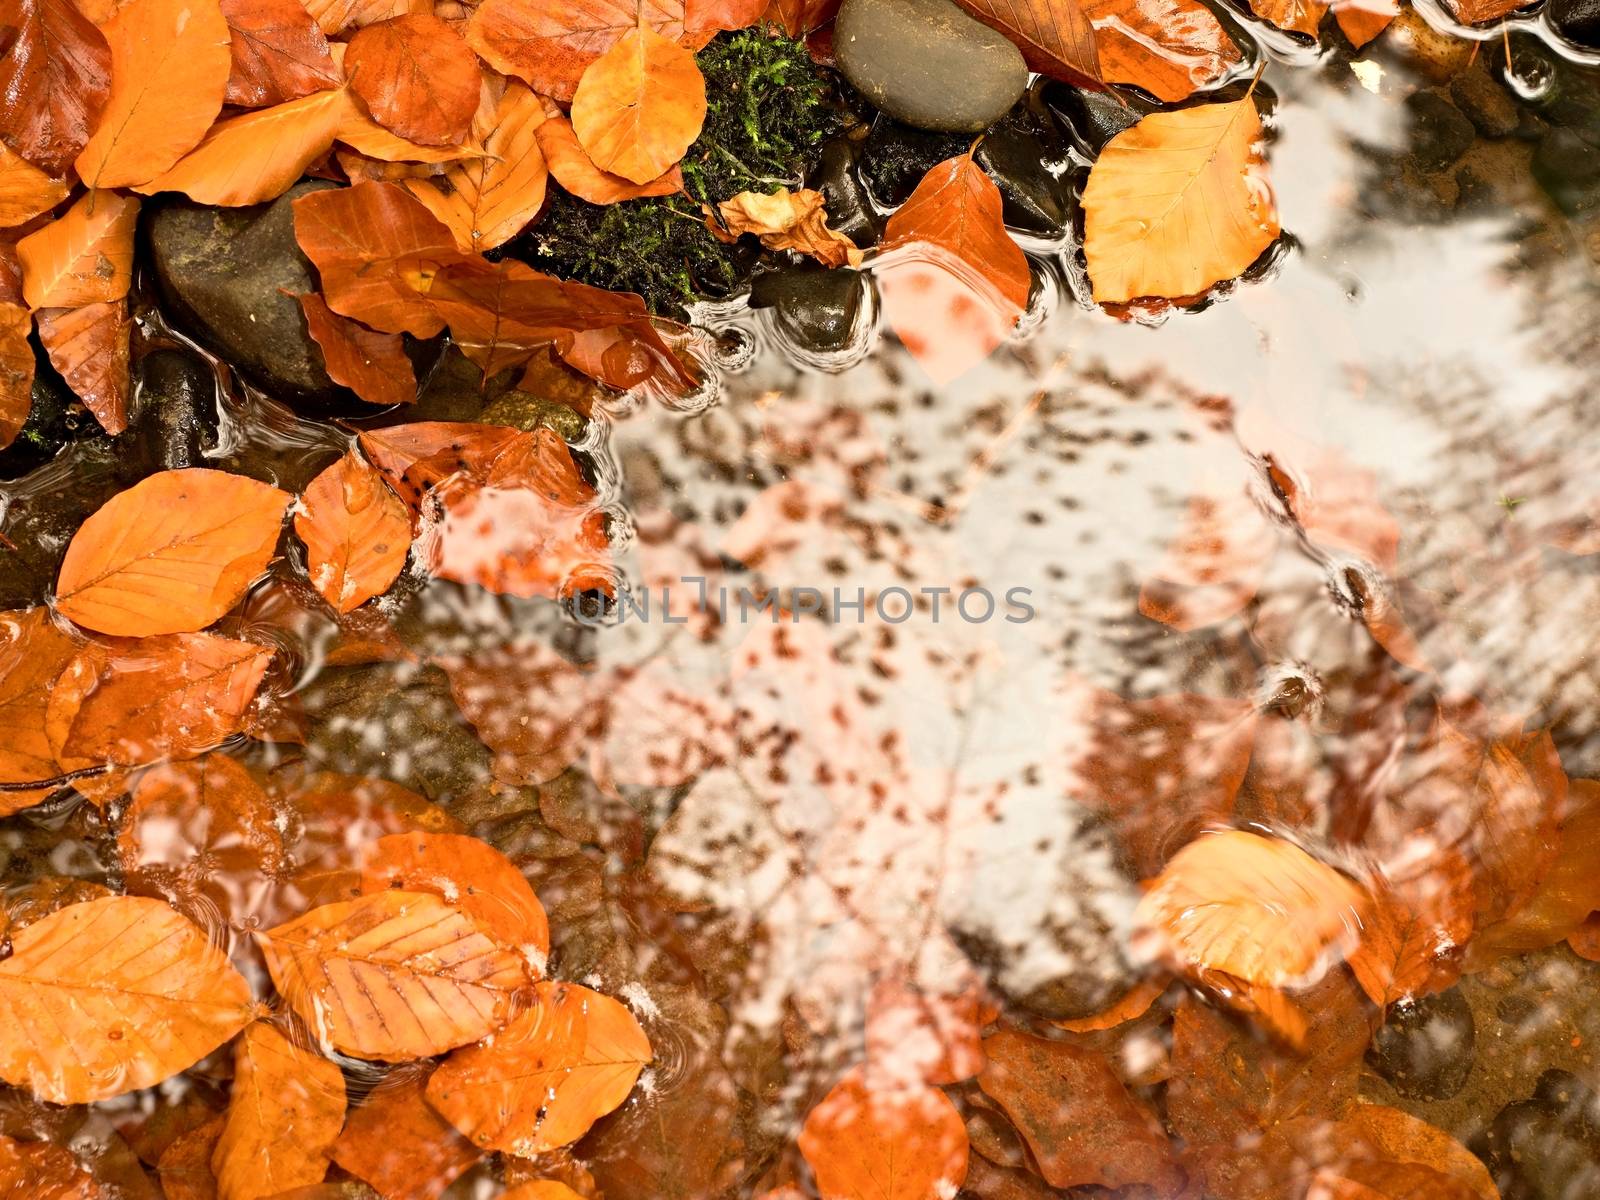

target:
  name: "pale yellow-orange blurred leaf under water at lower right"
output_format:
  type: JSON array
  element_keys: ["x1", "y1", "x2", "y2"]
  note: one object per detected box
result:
[{"x1": 1134, "y1": 830, "x2": 1368, "y2": 987}]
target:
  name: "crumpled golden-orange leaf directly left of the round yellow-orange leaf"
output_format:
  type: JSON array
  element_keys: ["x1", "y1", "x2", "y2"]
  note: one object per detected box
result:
[{"x1": 406, "y1": 80, "x2": 549, "y2": 253}]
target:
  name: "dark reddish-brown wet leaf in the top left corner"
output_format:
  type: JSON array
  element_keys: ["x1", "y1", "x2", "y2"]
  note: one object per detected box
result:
[{"x1": 0, "y1": 0, "x2": 110, "y2": 174}]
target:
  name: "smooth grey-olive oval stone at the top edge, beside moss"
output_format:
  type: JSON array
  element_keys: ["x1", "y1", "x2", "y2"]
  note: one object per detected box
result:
[{"x1": 834, "y1": 0, "x2": 1027, "y2": 133}]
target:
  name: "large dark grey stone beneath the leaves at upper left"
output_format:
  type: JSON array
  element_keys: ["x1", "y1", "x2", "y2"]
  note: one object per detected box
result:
[{"x1": 144, "y1": 179, "x2": 344, "y2": 411}]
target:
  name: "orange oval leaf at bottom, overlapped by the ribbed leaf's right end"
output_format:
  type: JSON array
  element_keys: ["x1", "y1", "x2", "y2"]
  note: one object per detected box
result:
[{"x1": 427, "y1": 982, "x2": 654, "y2": 1158}]
